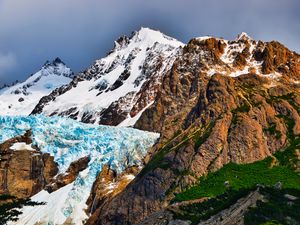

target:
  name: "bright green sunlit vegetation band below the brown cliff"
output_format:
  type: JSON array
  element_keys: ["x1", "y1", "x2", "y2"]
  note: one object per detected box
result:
[{"x1": 175, "y1": 157, "x2": 300, "y2": 201}]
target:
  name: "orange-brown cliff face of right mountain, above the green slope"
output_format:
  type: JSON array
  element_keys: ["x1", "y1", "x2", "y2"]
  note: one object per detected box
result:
[{"x1": 89, "y1": 34, "x2": 300, "y2": 224}]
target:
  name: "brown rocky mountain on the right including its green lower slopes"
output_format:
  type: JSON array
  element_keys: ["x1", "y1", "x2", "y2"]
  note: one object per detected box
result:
[{"x1": 87, "y1": 33, "x2": 300, "y2": 225}]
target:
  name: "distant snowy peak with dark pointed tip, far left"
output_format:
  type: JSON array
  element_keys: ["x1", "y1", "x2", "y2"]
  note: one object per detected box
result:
[{"x1": 0, "y1": 58, "x2": 73, "y2": 115}]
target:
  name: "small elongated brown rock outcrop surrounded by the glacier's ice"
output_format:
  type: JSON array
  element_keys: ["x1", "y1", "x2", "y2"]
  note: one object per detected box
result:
[{"x1": 45, "y1": 157, "x2": 90, "y2": 193}]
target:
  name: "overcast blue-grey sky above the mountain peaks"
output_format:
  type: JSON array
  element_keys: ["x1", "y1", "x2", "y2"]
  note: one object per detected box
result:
[{"x1": 0, "y1": 0, "x2": 300, "y2": 84}]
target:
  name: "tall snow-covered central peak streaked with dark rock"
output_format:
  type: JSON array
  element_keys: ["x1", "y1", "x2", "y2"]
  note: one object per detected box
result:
[{"x1": 32, "y1": 28, "x2": 183, "y2": 126}]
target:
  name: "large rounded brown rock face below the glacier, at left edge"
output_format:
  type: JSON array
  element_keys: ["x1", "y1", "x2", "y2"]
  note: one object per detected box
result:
[{"x1": 0, "y1": 131, "x2": 58, "y2": 198}]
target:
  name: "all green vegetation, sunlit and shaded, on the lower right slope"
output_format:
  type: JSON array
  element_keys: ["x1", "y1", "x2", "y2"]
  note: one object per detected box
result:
[{"x1": 173, "y1": 111, "x2": 300, "y2": 225}]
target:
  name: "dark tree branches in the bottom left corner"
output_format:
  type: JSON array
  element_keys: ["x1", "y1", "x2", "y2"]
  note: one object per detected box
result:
[{"x1": 0, "y1": 195, "x2": 45, "y2": 225}]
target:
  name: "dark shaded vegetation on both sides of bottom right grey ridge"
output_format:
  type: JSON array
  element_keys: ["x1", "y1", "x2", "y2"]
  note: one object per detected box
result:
[{"x1": 173, "y1": 187, "x2": 300, "y2": 225}]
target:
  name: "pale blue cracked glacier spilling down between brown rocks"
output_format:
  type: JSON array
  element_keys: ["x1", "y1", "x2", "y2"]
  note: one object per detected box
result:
[{"x1": 0, "y1": 115, "x2": 159, "y2": 225}]
